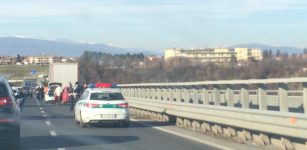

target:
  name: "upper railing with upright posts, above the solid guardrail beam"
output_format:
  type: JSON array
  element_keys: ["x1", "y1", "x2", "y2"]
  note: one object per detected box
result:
[{"x1": 119, "y1": 78, "x2": 307, "y2": 114}]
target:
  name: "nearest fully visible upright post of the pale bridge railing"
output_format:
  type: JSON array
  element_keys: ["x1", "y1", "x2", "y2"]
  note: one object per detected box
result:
[{"x1": 278, "y1": 83, "x2": 289, "y2": 112}]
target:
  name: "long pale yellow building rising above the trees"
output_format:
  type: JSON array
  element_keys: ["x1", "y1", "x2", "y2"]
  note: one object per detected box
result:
[{"x1": 164, "y1": 48, "x2": 263, "y2": 63}]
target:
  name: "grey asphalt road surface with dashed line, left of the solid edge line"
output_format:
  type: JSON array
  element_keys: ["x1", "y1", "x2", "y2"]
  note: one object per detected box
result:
[{"x1": 21, "y1": 99, "x2": 221, "y2": 150}]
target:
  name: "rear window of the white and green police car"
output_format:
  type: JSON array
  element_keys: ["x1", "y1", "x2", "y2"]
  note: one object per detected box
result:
[{"x1": 90, "y1": 92, "x2": 124, "y2": 101}]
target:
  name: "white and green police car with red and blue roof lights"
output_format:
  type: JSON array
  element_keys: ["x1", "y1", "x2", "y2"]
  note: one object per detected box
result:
[{"x1": 75, "y1": 83, "x2": 129, "y2": 128}]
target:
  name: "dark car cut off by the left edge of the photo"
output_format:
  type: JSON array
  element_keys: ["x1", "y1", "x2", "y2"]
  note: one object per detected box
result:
[{"x1": 0, "y1": 78, "x2": 20, "y2": 150}]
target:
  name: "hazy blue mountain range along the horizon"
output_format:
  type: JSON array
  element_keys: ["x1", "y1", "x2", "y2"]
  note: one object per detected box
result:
[{"x1": 0, "y1": 37, "x2": 303, "y2": 57}]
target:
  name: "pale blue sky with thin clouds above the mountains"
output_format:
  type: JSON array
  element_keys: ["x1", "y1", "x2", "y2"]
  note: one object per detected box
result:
[{"x1": 0, "y1": 0, "x2": 307, "y2": 50}]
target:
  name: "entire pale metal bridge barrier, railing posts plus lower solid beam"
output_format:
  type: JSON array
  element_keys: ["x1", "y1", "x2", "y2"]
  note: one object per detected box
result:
[{"x1": 118, "y1": 78, "x2": 307, "y2": 139}]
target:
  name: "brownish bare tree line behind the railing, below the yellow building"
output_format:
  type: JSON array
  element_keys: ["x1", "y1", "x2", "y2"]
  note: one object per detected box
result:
[{"x1": 79, "y1": 50, "x2": 307, "y2": 84}]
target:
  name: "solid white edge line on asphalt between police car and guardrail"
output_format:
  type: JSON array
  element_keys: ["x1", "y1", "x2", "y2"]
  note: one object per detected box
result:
[{"x1": 130, "y1": 118, "x2": 234, "y2": 150}]
